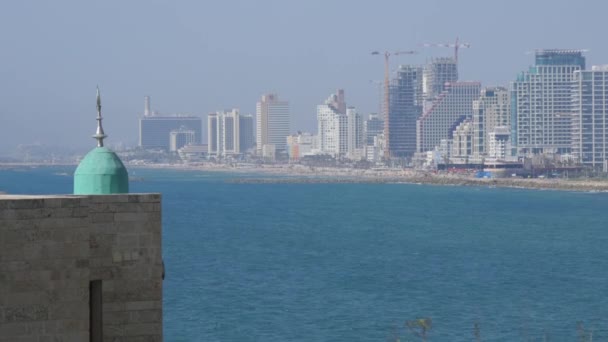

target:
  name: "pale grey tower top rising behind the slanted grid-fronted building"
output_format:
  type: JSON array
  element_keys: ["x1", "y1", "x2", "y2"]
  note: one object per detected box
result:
[{"x1": 422, "y1": 57, "x2": 458, "y2": 103}]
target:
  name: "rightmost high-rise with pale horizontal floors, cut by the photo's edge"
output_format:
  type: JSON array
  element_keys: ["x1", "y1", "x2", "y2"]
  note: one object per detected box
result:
[{"x1": 572, "y1": 65, "x2": 608, "y2": 171}]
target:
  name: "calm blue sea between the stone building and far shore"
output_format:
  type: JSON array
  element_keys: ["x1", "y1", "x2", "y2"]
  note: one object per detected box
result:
[{"x1": 0, "y1": 168, "x2": 608, "y2": 341}]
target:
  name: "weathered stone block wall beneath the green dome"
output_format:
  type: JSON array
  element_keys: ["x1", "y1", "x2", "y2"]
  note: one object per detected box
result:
[{"x1": 0, "y1": 194, "x2": 163, "y2": 342}]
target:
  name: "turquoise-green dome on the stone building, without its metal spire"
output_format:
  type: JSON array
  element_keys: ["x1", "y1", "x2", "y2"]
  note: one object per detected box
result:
[{"x1": 74, "y1": 147, "x2": 129, "y2": 195}]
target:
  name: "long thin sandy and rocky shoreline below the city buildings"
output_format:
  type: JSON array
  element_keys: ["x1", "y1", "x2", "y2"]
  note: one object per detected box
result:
[{"x1": 0, "y1": 163, "x2": 608, "y2": 192}]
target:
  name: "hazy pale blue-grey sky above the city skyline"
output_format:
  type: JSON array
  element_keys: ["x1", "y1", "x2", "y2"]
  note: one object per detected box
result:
[{"x1": 0, "y1": 0, "x2": 608, "y2": 152}]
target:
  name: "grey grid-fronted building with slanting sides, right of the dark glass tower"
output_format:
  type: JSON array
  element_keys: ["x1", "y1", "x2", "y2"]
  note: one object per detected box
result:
[{"x1": 416, "y1": 82, "x2": 481, "y2": 152}]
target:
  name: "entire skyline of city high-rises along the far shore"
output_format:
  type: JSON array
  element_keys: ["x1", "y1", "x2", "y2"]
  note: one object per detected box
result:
[{"x1": 135, "y1": 49, "x2": 608, "y2": 170}]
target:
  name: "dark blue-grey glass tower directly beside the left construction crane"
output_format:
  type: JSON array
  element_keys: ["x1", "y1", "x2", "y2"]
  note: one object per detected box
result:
[{"x1": 384, "y1": 65, "x2": 422, "y2": 158}]
